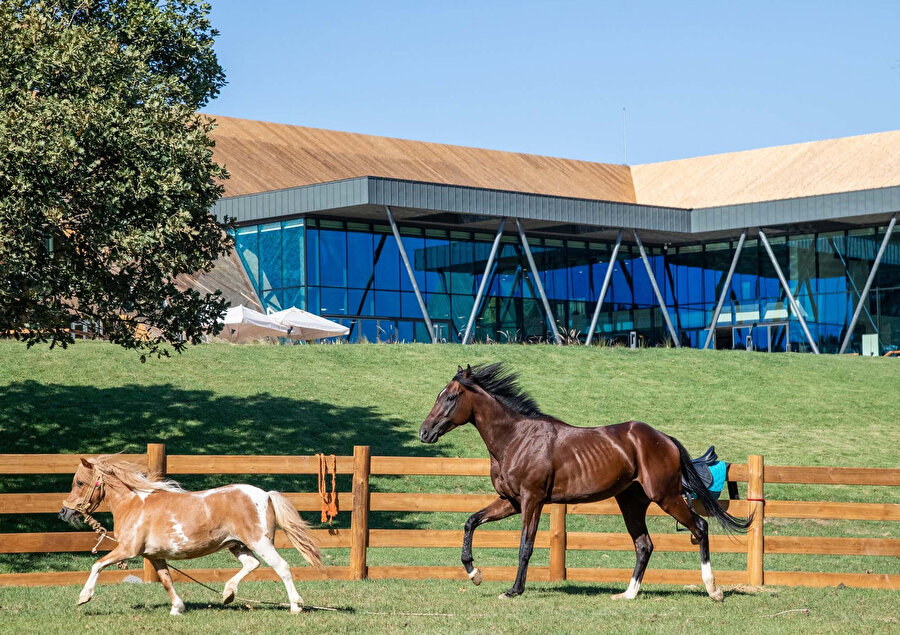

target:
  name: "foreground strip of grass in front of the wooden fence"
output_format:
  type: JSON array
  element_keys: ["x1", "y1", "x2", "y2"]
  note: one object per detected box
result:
[{"x1": 0, "y1": 580, "x2": 900, "y2": 635}]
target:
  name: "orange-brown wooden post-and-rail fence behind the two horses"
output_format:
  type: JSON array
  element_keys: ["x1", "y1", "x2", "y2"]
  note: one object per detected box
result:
[{"x1": 0, "y1": 444, "x2": 900, "y2": 589}]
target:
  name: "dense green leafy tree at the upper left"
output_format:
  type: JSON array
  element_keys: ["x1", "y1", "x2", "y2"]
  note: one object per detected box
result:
[{"x1": 0, "y1": 0, "x2": 230, "y2": 360}]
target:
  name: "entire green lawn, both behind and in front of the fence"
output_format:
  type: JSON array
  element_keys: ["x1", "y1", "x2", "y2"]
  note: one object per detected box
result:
[{"x1": 0, "y1": 341, "x2": 900, "y2": 632}]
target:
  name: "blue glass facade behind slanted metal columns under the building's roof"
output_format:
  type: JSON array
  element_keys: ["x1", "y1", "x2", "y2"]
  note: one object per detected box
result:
[{"x1": 235, "y1": 217, "x2": 900, "y2": 352}]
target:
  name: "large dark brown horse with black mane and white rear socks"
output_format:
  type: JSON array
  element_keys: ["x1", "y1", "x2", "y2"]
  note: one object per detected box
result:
[{"x1": 419, "y1": 363, "x2": 749, "y2": 601}]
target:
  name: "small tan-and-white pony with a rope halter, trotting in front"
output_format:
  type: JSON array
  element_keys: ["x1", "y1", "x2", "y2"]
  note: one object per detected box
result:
[{"x1": 59, "y1": 455, "x2": 322, "y2": 615}]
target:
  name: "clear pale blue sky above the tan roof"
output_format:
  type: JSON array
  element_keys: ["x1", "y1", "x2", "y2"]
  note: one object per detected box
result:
[{"x1": 204, "y1": 0, "x2": 900, "y2": 164}]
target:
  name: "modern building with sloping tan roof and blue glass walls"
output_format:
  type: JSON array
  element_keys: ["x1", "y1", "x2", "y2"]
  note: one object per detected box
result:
[{"x1": 206, "y1": 117, "x2": 900, "y2": 354}]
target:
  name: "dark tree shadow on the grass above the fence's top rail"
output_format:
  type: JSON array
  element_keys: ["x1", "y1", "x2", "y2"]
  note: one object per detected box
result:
[{"x1": 0, "y1": 381, "x2": 432, "y2": 456}]
